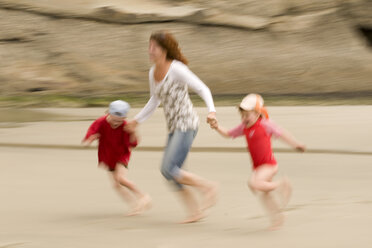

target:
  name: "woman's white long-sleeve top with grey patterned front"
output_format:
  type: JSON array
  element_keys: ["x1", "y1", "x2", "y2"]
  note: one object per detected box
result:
[{"x1": 135, "y1": 60, "x2": 216, "y2": 132}]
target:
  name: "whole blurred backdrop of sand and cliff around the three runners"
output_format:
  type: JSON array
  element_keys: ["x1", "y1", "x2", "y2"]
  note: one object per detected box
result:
[{"x1": 0, "y1": 0, "x2": 372, "y2": 248}]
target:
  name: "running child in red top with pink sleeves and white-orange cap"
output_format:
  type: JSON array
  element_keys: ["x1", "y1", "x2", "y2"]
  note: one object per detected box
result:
[{"x1": 211, "y1": 94, "x2": 305, "y2": 229}]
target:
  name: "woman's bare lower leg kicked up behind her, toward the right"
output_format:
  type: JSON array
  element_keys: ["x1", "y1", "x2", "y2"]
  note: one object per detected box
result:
[{"x1": 177, "y1": 170, "x2": 217, "y2": 210}]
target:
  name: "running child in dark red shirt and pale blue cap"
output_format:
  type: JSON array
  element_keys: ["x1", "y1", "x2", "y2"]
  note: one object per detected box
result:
[{"x1": 83, "y1": 100, "x2": 151, "y2": 215}]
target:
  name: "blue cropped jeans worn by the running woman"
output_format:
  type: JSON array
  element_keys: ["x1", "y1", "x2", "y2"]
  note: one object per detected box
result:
[{"x1": 161, "y1": 130, "x2": 197, "y2": 189}]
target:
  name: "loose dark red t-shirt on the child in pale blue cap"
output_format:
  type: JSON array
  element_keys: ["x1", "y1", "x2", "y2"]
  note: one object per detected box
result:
[{"x1": 84, "y1": 115, "x2": 137, "y2": 170}]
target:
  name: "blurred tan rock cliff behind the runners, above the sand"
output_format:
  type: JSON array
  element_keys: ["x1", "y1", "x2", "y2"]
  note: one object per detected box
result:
[{"x1": 0, "y1": 0, "x2": 372, "y2": 107}]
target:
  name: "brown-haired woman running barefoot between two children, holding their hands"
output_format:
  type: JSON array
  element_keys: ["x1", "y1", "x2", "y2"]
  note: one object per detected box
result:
[{"x1": 127, "y1": 31, "x2": 217, "y2": 223}]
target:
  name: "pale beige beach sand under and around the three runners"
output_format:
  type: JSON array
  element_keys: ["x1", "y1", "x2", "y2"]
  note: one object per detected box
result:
[{"x1": 0, "y1": 106, "x2": 372, "y2": 248}]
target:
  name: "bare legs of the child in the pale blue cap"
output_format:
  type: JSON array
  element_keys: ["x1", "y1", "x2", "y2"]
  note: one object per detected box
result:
[{"x1": 113, "y1": 164, "x2": 151, "y2": 214}]
